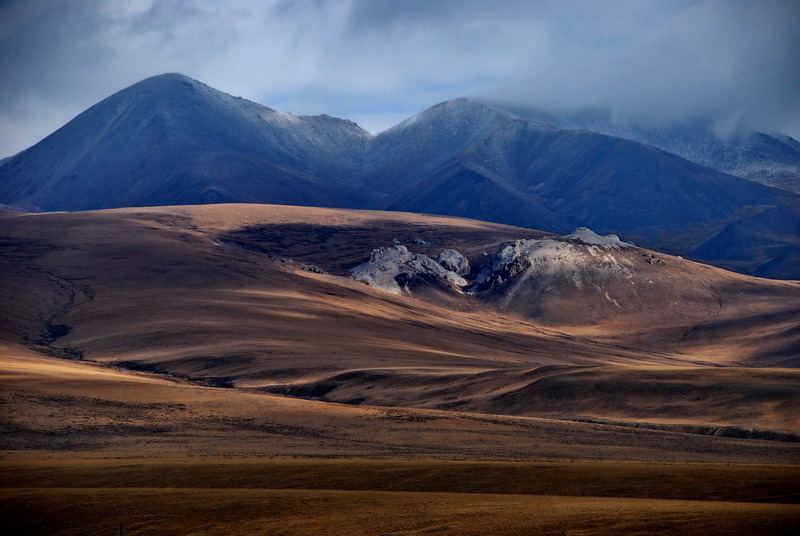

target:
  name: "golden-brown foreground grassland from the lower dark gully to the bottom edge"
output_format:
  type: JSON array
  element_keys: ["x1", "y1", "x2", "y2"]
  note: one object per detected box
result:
[{"x1": 0, "y1": 348, "x2": 800, "y2": 535}]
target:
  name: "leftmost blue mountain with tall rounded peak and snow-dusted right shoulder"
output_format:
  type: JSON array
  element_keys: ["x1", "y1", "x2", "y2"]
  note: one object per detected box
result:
[{"x1": 0, "y1": 74, "x2": 370, "y2": 210}]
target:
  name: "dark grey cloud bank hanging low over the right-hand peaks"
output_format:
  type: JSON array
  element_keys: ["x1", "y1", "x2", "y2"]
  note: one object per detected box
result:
[{"x1": 484, "y1": 1, "x2": 800, "y2": 137}]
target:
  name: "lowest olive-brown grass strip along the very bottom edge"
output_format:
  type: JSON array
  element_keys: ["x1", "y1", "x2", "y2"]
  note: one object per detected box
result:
[{"x1": 0, "y1": 488, "x2": 800, "y2": 536}]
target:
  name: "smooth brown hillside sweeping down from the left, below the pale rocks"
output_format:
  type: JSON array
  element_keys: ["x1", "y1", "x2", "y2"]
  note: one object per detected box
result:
[{"x1": 3, "y1": 206, "x2": 689, "y2": 377}]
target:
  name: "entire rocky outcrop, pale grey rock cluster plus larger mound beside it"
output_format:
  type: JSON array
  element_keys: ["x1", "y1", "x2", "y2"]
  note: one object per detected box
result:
[{"x1": 352, "y1": 227, "x2": 680, "y2": 324}]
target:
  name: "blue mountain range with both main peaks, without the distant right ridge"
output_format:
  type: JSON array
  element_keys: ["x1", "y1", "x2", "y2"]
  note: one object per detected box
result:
[{"x1": 0, "y1": 74, "x2": 800, "y2": 278}]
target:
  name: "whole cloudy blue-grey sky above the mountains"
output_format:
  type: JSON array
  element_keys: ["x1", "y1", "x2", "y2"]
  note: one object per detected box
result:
[{"x1": 0, "y1": 0, "x2": 800, "y2": 157}]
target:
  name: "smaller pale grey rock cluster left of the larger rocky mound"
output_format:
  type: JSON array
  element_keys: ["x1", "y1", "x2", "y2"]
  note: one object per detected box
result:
[{"x1": 351, "y1": 245, "x2": 468, "y2": 294}]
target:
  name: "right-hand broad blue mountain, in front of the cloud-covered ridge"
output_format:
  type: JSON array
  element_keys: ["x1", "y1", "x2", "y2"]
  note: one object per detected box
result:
[{"x1": 370, "y1": 99, "x2": 800, "y2": 278}]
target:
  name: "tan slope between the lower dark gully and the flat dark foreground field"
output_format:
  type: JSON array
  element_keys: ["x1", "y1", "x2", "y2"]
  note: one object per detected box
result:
[{"x1": 0, "y1": 345, "x2": 800, "y2": 462}]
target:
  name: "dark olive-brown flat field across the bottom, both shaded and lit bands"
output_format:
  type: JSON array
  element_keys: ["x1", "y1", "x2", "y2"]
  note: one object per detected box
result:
[{"x1": 0, "y1": 458, "x2": 800, "y2": 535}]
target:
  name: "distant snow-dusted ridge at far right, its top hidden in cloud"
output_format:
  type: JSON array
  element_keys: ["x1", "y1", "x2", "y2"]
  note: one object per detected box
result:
[{"x1": 487, "y1": 103, "x2": 800, "y2": 193}]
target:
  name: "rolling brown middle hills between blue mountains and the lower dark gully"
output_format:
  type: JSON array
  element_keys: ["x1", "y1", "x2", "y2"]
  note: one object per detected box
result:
[{"x1": 0, "y1": 205, "x2": 800, "y2": 433}]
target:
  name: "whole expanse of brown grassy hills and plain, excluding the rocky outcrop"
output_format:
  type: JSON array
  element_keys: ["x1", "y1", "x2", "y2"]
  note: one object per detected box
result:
[{"x1": 0, "y1": 205, "x2": 800, "y2": 535}]
